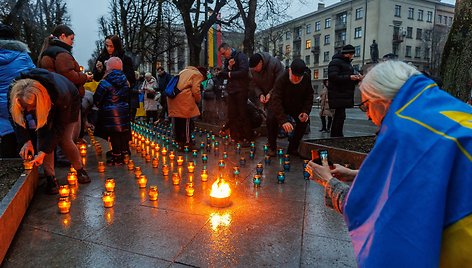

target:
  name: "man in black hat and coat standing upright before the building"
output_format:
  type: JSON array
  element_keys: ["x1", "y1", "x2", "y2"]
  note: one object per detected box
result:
[{"x1": 328, "y1": 45, "x2": 362, "y2": 137}]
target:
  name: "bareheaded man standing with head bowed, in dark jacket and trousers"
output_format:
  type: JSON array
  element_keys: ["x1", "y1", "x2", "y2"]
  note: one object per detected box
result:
[{"x1": 218, "y1": 43, "x2": 252, "y2": 147}]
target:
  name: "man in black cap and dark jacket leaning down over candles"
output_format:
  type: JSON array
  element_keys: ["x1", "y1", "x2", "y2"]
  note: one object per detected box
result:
[{"x1": 267, "y1": 59, "x2": 313, "y2": 156}]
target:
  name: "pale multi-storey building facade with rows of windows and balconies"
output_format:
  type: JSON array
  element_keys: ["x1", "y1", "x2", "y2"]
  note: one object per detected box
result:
[{"x1": 256, "y1": 0, "x2": 454, "y2": 91}]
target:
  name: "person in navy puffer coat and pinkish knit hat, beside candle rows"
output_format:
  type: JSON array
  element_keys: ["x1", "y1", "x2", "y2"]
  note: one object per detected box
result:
[{"x1": 93, "y1": 57, "x2": 131, "y2": 165}]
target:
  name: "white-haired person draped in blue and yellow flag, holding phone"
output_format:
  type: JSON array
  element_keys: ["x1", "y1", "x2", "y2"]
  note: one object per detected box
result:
[{"x1": 307, "y1": 61, "x2": 472, "y2": 267}]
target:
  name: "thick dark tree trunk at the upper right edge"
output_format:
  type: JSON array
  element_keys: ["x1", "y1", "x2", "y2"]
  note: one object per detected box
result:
[{"x1": 441, "y1": 0, "x2": 472, "y2": 101}]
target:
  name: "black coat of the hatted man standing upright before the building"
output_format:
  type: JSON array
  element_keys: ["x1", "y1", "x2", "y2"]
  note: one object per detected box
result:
[{"x1": 328, "y1": 54, "x2": 357, "y2": 109}]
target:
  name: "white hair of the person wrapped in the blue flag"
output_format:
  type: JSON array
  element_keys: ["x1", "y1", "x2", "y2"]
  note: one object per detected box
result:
[{"x1": 360, "y1": 60, "x2": 421, "y2": 100}]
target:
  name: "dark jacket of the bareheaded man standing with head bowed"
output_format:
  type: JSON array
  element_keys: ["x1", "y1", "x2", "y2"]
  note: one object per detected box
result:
[{"x1": 219, "y1": 49, "x2": 249, "y2": 95}]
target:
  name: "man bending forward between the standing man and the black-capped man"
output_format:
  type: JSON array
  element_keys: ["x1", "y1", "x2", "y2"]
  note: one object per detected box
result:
[{"x1": 249, "y1": 52, "x2": 285, "y2": 104}]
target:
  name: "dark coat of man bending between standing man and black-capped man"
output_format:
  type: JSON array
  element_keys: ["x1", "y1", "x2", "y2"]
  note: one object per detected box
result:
[{"x1": 250, "y1": 52, "x2": 285, "y2": 98}]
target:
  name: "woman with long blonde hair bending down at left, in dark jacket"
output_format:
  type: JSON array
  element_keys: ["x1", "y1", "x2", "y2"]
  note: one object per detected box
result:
[{"x1": 9, "y1": 68, "x2": 91, "y2": 194}]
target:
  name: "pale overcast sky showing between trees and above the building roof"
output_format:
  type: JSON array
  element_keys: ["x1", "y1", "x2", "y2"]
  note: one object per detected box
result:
[{"x1": 66, "y1": 0, "x2": 455, "y2": 66}]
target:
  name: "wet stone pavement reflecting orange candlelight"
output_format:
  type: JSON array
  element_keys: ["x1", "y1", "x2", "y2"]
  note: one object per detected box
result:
[{"x1": 2, "y1": 110, "x2": 375, "y2": 267}]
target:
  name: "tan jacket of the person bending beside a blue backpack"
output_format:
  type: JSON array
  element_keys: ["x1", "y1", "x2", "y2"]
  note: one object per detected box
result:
[{"x1": 167, "y1": 66, "x2": 203, "y2": 118}]
